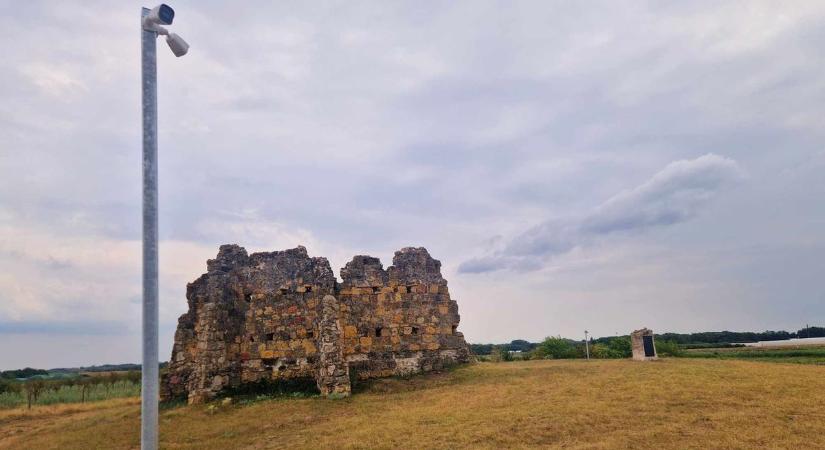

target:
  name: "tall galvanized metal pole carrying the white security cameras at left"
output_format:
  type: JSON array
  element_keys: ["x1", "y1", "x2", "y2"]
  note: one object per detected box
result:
[{"x1": 140, "y1": 8, "x2": 158, "y2": 450}]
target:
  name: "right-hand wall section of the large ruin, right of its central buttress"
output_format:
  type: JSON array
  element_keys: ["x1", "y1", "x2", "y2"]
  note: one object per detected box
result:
[{"x1": 339, "y1": 248, "x2": 469, "y2": 378}]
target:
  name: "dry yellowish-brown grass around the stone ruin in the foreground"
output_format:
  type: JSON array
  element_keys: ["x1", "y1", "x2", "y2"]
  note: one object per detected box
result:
[{"x1": 0, "y1": 358, "x2": 825, "y2": 449}]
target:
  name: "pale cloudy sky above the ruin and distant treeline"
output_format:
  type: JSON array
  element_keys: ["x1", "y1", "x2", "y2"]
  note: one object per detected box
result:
[{"x1": 0, "y1": 0, "x2": 825, "y2": 369}]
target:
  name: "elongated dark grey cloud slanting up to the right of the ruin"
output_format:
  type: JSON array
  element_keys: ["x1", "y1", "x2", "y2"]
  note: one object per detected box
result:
[{"x1": 459, "y1": 154, "x2": 744, "y2": 273}]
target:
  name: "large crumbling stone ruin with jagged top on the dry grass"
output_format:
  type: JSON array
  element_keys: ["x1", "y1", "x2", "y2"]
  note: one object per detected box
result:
[{"x1": 161, "y1": 245, "x2": 471, "y2": 403}]
